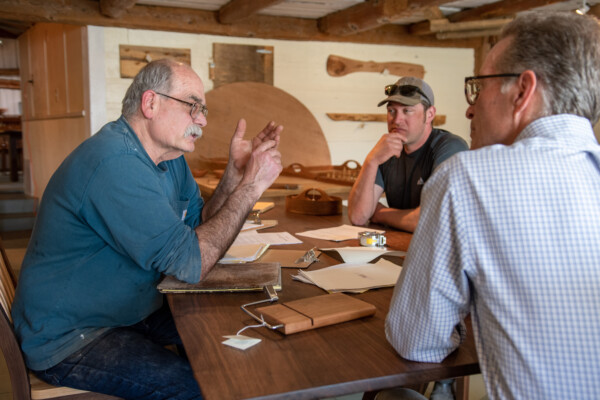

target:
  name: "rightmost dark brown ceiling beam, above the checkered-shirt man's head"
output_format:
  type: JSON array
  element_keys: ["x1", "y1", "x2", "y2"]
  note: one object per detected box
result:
[{"x1": 448, "y1": 0, "x2": 564, "y2": 22}]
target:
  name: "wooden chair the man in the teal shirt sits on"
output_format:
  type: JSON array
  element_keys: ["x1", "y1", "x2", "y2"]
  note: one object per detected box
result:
[{"x1": 0, "y1": 239, "x2": 117, "y2": 400}]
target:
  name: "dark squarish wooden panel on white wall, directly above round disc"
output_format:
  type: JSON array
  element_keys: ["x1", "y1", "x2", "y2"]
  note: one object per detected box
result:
[{"x1": 210, "y1": 43, "x2": 274, "y2": 88}]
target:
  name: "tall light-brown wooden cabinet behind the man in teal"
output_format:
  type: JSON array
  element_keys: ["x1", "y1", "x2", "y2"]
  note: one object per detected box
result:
[{"x1": 19, "y1": 23, "x2": 90, "y2": 197}]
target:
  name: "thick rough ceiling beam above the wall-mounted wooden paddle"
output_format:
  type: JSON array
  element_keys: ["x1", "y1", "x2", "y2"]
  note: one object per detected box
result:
[{"x1": 319, "y1": 0, "x2": 458, "y2": 36}]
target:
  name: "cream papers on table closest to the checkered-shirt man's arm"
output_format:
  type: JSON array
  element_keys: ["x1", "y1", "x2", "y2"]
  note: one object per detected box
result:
[{"x1": 292, "y1": 259, "x2": 402, "y2": 293}]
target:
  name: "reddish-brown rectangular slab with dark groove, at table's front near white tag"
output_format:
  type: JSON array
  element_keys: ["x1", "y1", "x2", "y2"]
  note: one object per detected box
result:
[{"x1": 256, "y1": 293, "x2": 376, "y2": 335}]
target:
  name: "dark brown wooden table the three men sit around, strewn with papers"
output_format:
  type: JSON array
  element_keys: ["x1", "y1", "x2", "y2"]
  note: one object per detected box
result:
[{"x1": 168, "y1": 201, "x2": 479, "y2": 400}]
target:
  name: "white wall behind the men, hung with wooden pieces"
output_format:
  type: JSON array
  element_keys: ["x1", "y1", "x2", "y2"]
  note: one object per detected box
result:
[{"x1": 89, "y1": 27, "x2": 474, "y2": 164}]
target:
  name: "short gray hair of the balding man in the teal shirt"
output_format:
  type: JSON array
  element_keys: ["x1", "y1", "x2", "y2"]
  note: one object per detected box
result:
[{"x1": 121, "y1": 59, "x2": 177, "y2": 118}]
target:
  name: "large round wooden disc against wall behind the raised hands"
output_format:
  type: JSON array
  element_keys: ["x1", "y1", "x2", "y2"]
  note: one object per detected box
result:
[{"x1": 185, "y1": 82, "x2": 331, "y2": 169}]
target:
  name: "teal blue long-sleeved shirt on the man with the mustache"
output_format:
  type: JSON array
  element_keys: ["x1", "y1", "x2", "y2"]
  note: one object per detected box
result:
[{"x1": 12, "y1": 117, "x2": 204, "y2": 370}]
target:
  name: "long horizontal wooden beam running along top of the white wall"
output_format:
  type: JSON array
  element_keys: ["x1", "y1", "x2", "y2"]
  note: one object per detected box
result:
[{"x1": 0, "y1": 0, "x2": 479, "y2": 48}]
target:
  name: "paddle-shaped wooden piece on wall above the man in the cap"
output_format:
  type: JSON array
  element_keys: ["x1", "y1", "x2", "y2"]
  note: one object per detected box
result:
[{"x1": 327, "y1": 54, "x2": 425, "y2": 79}]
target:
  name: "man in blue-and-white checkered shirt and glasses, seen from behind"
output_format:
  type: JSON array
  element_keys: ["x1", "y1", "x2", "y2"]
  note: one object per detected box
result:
[{"x1": 378, "y1": 11, "x2": 600, "y2": 399}]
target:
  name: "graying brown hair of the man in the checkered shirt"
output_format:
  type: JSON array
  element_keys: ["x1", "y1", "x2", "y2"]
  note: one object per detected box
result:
[{"x1": 496, "y1": 11, "x2": 600, "y2": 124}]
